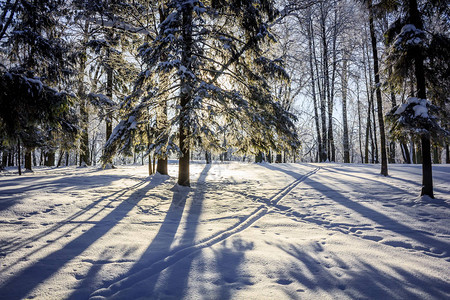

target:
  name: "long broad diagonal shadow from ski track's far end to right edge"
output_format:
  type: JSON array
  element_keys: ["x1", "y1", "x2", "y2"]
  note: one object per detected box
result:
[{"x1": 267, "y1": 165, "x2": 450, "y2": 257}]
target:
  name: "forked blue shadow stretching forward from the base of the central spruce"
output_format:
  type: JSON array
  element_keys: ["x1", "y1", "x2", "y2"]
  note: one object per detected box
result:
[{"x1": 91, "y1": 164, "x2": 211, "y2": 299}]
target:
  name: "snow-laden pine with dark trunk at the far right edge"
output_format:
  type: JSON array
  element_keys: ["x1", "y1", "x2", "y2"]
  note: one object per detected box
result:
[{"x1": 386, "y1": 0, "x2": 448, "y2": 198}]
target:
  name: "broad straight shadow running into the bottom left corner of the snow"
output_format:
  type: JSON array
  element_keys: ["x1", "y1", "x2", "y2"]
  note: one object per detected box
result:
[{"x1": 0, "y1": 178, "x2": 166, "y2": 300}]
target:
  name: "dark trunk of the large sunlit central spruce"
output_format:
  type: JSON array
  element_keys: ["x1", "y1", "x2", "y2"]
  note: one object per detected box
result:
[{"x1": 178, "y1": 5, "x2": 193, "y2": 186}]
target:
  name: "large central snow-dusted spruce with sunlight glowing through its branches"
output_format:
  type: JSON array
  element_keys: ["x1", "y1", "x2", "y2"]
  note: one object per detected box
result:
[{"x1": 104, "y1": 0, "x2": 298, "y2": 185}]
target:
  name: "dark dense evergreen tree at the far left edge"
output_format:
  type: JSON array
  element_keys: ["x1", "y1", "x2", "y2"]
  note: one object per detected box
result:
[{"x1": 0, "y1": 0, "x2": 77, "y2": 174}]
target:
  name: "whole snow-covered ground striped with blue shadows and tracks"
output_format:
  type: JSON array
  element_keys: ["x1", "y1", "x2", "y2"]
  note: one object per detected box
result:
[{"x1": 0, "y1": 163, "x2": 450, "y2": 299}]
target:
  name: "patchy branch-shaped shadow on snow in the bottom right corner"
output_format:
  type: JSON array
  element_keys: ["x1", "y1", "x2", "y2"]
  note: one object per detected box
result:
[{"x1": 277, "y1": 244, "x2": 449, "y2": 299}]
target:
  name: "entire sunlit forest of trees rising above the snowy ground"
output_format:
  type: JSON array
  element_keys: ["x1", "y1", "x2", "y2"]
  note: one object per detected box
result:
[{"x1": 0, "y1": 0, "x2": 450, "y2": 185}]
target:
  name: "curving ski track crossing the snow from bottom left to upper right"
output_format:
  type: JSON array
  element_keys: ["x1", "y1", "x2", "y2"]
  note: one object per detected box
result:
[{"x1": 89, "y1": 167, "x2": 321, "y2": 300}]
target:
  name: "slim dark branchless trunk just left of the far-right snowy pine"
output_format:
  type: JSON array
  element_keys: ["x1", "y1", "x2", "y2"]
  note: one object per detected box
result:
[{"x1": 368, "y1": 0, "x2": 388, "y2": 176}]
